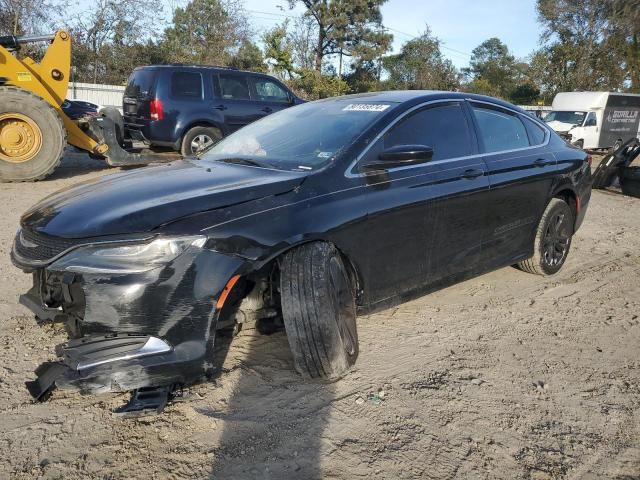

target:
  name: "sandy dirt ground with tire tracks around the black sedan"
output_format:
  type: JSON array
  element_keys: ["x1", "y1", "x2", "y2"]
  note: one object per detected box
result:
[{"x1": 0, "y1": 154, "x2": 640, "y2": 479}]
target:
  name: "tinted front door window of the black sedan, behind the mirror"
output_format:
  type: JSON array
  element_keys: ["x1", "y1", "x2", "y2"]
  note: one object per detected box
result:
[{"x1": 384, "y1": 103, "x2": 473, "y2": 160}]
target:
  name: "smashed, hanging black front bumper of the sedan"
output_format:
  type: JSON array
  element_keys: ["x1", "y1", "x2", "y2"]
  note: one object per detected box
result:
[{"x1": 15, "y1": 249, "x2": 243, "y2": 400}]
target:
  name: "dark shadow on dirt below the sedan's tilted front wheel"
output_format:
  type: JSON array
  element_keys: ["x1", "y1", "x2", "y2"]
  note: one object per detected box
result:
[{"x1": 197, "y1": 324, "x2": 335, "y2": 480}]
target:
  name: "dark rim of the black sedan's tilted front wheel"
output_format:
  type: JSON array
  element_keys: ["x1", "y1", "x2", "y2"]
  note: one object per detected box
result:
[{"x1": 329, "y1": 257, "x2": 358, "y2": 355}]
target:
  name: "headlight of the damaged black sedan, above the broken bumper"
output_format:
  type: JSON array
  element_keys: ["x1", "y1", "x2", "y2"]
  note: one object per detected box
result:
[{"x1": 49, "y1": 235, "x2": 207, "y2": 273}]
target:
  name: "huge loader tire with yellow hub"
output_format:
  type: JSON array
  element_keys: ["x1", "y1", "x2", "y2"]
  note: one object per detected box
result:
[{"x1": 0, "y1": 86, "x2": 67, "y2": 182}]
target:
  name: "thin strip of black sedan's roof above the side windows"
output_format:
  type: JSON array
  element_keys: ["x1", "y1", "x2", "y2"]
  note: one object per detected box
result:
[{"x1": 327, "y1": 90, "x2": 526, "y2": 113}]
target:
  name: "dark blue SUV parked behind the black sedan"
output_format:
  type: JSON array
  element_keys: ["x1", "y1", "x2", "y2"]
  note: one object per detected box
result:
[{"x1": 122, "y1": 65, "x2": 304, "y2": 156}]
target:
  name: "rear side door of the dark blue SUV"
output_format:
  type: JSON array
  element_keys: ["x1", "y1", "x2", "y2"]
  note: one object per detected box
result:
[{"x1": 213, "y1": 72, "x2": 262, "y2": 133}]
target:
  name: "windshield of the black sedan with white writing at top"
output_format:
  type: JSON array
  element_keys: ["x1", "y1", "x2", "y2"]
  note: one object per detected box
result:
[{"x1": 202, "y1": 98, "x2": 395, "y2": 171}]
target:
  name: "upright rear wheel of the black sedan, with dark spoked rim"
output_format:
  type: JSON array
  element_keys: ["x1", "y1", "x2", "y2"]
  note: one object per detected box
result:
[{"x1": 518, "y1": 198, "x2": 575, "y2": 275}]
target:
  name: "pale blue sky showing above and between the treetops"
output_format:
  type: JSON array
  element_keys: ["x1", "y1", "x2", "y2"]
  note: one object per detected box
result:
[{"x1": 245, "y1": 0, "x2": 540, "y2": 68}]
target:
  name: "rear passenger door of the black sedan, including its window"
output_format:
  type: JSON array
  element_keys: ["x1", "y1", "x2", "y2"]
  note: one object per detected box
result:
[{"x1": 470, "y1": 102, "x2": 556, "y2": 268}]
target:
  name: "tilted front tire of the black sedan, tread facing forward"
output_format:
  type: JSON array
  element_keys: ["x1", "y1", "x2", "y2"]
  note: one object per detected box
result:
[{"x1": 280, "y1": 242, "x2": 358, "y2": 379}]
